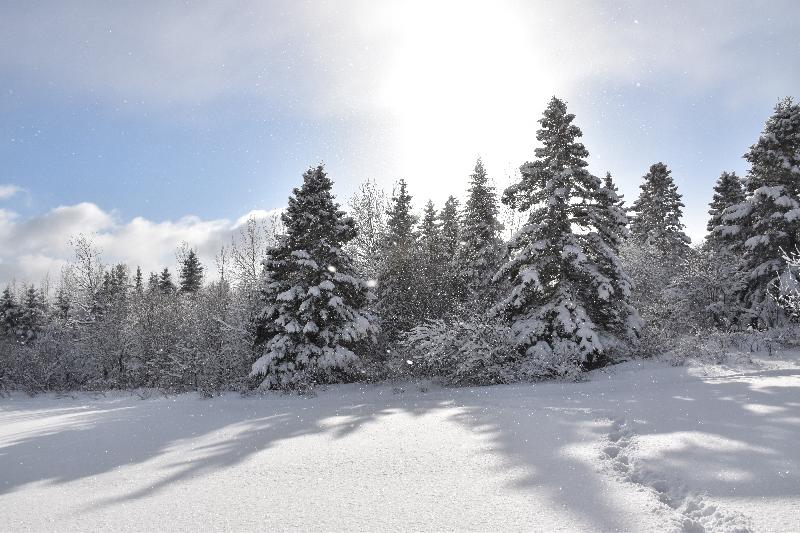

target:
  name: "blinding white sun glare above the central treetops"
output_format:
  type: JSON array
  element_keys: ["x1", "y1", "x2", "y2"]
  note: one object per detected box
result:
[{"x1": 378, "y1": 2, "x2": 553, "y2": 201}]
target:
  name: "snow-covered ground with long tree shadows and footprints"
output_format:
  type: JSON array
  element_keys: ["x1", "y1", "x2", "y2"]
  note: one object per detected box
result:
[{"x1": 0, "y1": 355, "x2": 800, "y2": 532}]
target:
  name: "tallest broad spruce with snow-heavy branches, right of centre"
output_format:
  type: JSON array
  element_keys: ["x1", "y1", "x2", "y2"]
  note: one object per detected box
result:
[{"x1": 495, "y1": 98, "x2": 631, "y2": 372}]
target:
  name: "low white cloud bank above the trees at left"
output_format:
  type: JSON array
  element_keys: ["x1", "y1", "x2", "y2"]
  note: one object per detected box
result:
[{"x1": 0, "y1": 203, "x2": 278, "y2": 286}]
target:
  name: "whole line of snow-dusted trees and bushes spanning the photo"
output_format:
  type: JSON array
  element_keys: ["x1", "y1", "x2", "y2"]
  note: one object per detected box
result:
[{"x1": 0, "y1": 98, "x2": 800, "y2": 394}]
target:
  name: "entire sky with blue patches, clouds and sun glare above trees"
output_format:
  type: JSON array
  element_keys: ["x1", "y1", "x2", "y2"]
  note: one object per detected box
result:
[{"x1": 0, "y1": 0, "x2": 800, "y2": 284}]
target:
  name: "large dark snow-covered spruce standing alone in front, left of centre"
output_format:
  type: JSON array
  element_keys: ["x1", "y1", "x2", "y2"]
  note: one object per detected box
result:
[{"x1": 252, "y1": 165, "x2": 374, "y2": 388}]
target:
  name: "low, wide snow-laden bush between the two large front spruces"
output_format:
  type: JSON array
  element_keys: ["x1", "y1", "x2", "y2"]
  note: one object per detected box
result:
[{"x1": 401, "y1": 316, "x2": 580, "y2": 386}]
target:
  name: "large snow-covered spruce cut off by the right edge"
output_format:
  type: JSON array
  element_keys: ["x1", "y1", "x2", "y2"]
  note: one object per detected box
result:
[{"x1": 717, "y1": 98, "x2": 800, "y2": 327}]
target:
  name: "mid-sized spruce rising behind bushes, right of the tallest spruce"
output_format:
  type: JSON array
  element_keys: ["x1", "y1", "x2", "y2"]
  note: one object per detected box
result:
[{"x1": 631, "y1": 163, "x2": 691, "y2": 257}]
